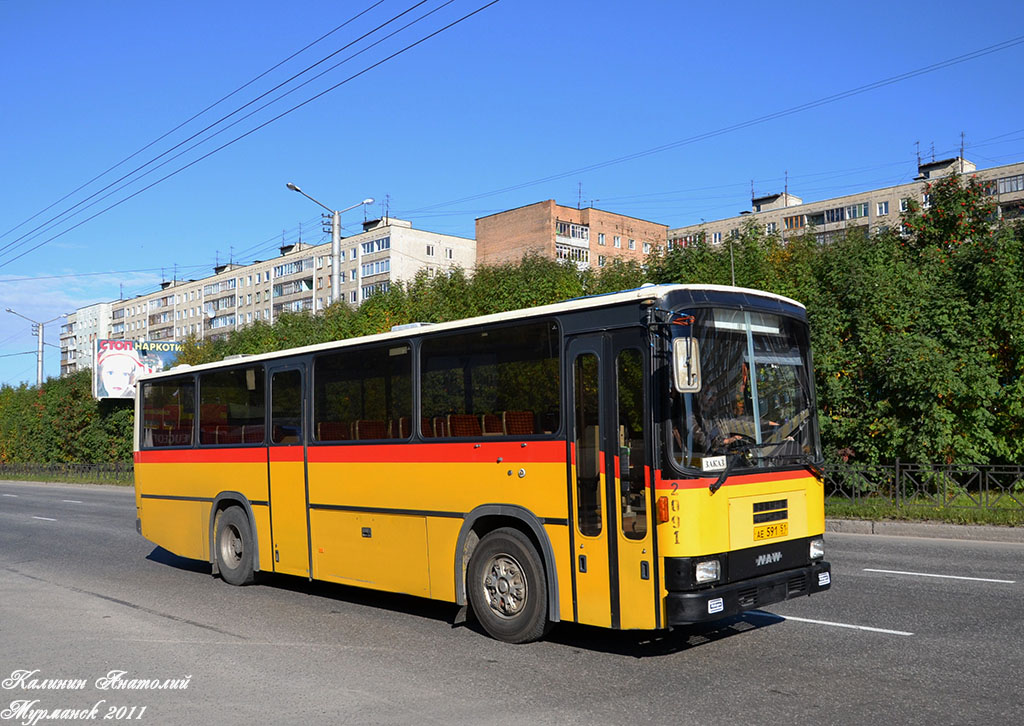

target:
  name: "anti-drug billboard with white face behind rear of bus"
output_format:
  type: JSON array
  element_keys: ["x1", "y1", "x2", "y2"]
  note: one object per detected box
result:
[{"x1": 92, "y1": 340, "x2": 181, "y2": 398}]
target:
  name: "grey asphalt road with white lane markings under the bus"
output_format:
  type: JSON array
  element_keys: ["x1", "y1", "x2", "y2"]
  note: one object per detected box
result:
[{"x1": 0, "y1": 482, "x2": 1024, "y2": 726}]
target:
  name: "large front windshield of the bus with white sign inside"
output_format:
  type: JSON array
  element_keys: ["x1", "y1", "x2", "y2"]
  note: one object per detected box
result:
[{"x1": 671, "y1": 308, "x2": 820, "y2": 472}]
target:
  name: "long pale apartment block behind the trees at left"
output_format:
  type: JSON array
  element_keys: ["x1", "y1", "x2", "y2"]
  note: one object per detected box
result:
[{"x1": 60, "y1": 211, "x2": 476, "y2": 364}]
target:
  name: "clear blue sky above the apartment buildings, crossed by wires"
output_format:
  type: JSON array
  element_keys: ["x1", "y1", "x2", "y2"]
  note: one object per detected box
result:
[{"x1": 0, "y1": 0, "x2": 1024, "y2": 384}]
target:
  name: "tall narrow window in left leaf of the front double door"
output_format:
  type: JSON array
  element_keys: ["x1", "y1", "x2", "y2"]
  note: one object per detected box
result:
[{"x1": 572, "y1": 353, "x2": 601, "y2": 537}]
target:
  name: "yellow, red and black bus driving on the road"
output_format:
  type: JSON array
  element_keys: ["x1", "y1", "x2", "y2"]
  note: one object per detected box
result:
[{"x1": 135, "y1": 285, "x2": 830, "y2": 642}]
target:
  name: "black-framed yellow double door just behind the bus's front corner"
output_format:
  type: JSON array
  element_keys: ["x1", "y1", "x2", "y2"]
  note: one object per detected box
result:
[{"x1": 566, "y1": 330, "x2": 657, "y2": 629}]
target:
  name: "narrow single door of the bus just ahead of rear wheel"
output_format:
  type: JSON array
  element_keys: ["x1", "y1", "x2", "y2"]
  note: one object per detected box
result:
[{"x1": 268, "y1": 366, "x2": 309, "y2": 576}]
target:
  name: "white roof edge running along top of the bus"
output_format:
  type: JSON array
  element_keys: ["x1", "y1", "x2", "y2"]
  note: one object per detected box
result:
[{"x1": 139, "y1": 285, "x2": 805, "y2": 381}]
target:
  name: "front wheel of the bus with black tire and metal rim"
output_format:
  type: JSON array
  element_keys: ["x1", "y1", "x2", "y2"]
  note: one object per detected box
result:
[{"x1": 468, "y1": 527, "x2": 549, "y2": 643}]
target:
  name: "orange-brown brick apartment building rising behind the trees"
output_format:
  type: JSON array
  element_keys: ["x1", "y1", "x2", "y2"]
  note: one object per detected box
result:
[{"x1": 476, "y1": 200, "x2": 669, "y2": 269}]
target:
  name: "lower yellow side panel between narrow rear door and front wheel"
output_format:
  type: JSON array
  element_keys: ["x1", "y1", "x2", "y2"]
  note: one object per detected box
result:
[{"x1": 309, "y1": 509, "x2": 428, "y2": 597}]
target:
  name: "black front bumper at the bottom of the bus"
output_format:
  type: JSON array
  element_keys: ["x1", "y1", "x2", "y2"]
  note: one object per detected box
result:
[{"x1": 666, "y1": 562, "x2": 831, "y2": 626}]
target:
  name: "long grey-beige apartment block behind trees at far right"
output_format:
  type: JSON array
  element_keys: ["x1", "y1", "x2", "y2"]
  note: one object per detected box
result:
[{"x1": 669, "y1": 157, "x2": 1024, "y2": 245}]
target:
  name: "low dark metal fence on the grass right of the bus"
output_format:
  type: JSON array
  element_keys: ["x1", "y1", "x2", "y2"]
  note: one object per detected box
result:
[{"x1": 824, "y1": 460, "x2": 1024, "y2": 509}]
